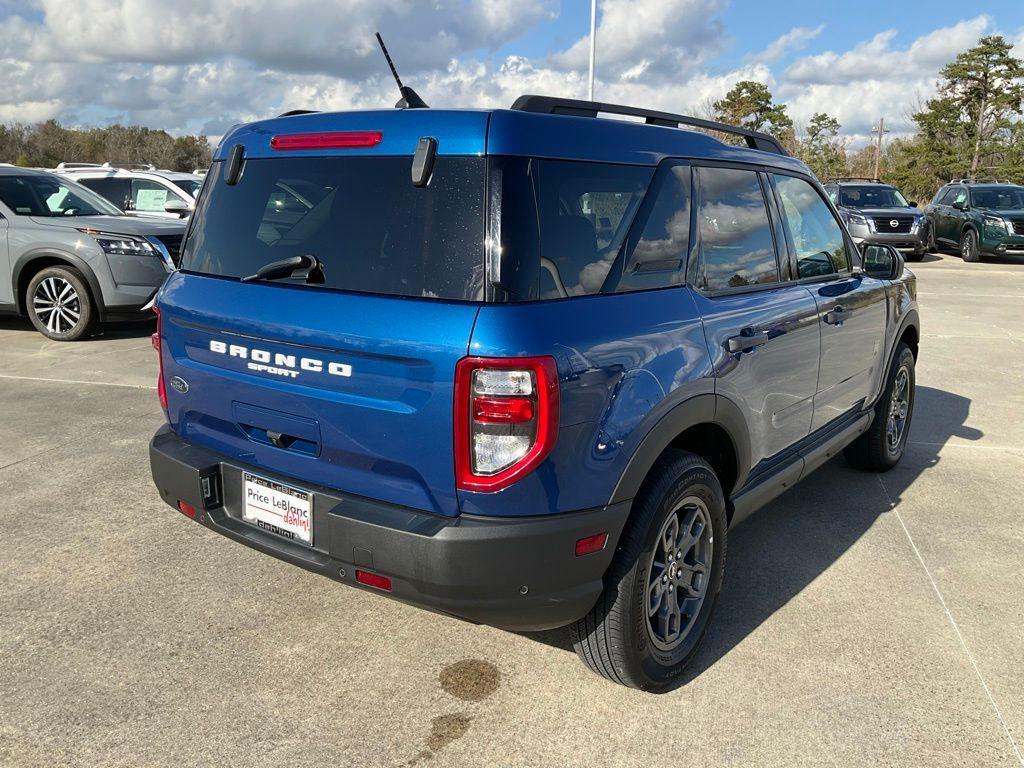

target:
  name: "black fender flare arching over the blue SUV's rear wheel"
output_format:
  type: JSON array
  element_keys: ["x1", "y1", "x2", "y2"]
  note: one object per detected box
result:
[{"x1": 609, "y1": 393, "x2": 751, "y2": 504}]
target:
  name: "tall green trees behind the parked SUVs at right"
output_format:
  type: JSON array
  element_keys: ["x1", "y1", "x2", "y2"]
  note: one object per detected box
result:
[{"x1": 703, "y1": 35, "x2": 1024, "y2": 201}]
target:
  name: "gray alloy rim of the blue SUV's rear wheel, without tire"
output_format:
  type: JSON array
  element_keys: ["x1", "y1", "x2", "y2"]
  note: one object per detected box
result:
[{"x1": 646, "y1": 497, "x2": 715, "y2": 651}]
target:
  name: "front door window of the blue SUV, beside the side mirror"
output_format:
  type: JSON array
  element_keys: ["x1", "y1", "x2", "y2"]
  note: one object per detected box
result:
[{"x1": 773, "y1": 175, "x2": 850, "y2": 278}]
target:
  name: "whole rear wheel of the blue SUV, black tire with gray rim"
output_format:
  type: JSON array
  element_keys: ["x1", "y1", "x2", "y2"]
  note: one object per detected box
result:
[{"x1": 570, "y1": 452, "x2": 727, "y2": 691}]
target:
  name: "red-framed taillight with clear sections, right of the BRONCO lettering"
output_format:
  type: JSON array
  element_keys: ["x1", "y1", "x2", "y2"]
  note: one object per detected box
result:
[{"x1": 455, "y1": 357, "x2": 558, "y2": 490}]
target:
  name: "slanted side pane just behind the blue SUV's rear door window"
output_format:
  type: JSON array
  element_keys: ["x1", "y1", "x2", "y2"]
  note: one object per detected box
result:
[{"x1": 615, "y1": 165, "x2": 690, "y2": 292}]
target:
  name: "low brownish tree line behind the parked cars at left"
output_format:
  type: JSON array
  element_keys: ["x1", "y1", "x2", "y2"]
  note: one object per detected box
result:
[{"x1": 0, "y1": 120, "x2": 211, "y2": 171}]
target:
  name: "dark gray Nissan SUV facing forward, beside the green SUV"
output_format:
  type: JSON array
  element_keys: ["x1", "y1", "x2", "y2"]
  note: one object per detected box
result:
[{"x1": 824, "y1": 178, "x2": 931, "y2": 261}]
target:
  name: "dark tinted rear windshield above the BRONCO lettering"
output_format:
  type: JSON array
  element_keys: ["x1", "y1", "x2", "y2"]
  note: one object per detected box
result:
[{"x1": 181, "y1": 157, "x2": 485, "y2": 301}]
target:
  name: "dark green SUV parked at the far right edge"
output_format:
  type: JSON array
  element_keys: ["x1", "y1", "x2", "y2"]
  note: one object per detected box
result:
[{"x1": 925, "y1": 179, "x2": 1024, "y2": 261}]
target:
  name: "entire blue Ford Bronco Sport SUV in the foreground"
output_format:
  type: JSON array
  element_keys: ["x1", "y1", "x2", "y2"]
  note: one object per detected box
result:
[{"x1": 150, "y1": 96, "x2": 920, "y2": 691}]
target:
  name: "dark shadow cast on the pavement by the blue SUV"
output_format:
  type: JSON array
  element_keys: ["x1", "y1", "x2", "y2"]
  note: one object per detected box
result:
[{"x1": 528, "y1": 386, "x2": 983, "y2": 686}]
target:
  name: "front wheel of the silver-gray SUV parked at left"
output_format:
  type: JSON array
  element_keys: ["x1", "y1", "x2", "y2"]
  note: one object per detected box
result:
[{"x1": 25, "y1": 265, "x2": 96, "y2": 341}]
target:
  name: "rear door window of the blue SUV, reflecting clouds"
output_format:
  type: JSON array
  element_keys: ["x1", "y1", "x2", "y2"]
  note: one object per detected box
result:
[{"x1": 697, "y1": 168, "x2": 779, "y2": 291}]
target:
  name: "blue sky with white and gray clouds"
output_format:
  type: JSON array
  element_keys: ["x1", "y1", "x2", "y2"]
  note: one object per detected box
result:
[{"x1": 0, "y1": 0, "x2": 1024, "y2": 144}]
